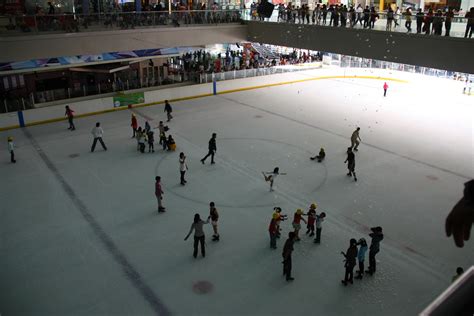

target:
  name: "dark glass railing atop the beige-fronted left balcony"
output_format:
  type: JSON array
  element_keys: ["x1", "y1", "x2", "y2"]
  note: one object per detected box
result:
[{"x1": 0, "y1": 10, "x2": 241, "y2": 35}]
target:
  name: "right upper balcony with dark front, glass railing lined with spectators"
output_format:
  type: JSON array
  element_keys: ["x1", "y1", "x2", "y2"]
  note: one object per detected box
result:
[{"x1": 243, "y1": 10, "x2": 474, "y2": 73}]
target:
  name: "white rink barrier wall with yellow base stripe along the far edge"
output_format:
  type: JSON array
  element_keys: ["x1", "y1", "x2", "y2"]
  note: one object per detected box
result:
[{"x1": 0, "y1": 68, "x2": 411, "y2": 131}]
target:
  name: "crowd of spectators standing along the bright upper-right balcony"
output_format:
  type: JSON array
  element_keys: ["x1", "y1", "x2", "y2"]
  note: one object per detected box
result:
[{"x1": 277, "y1": 3, "x2": 474, "y2": 38}]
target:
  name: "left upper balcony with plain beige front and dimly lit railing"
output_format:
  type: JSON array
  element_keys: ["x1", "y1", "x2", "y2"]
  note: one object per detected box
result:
[{"x1": 0, "y1": 10, "x2": 247, "y2": 62}]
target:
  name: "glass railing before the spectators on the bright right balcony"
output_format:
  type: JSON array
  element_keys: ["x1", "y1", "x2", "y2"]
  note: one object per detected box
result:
[{"x1": 242, "y1": 9, "x2": 474, "y2": 38}]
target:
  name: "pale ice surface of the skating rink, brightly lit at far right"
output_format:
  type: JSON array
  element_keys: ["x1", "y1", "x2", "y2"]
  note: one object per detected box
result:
[{"x1": 0, "y1": 69, "x2": 474, "y2": 315}]
